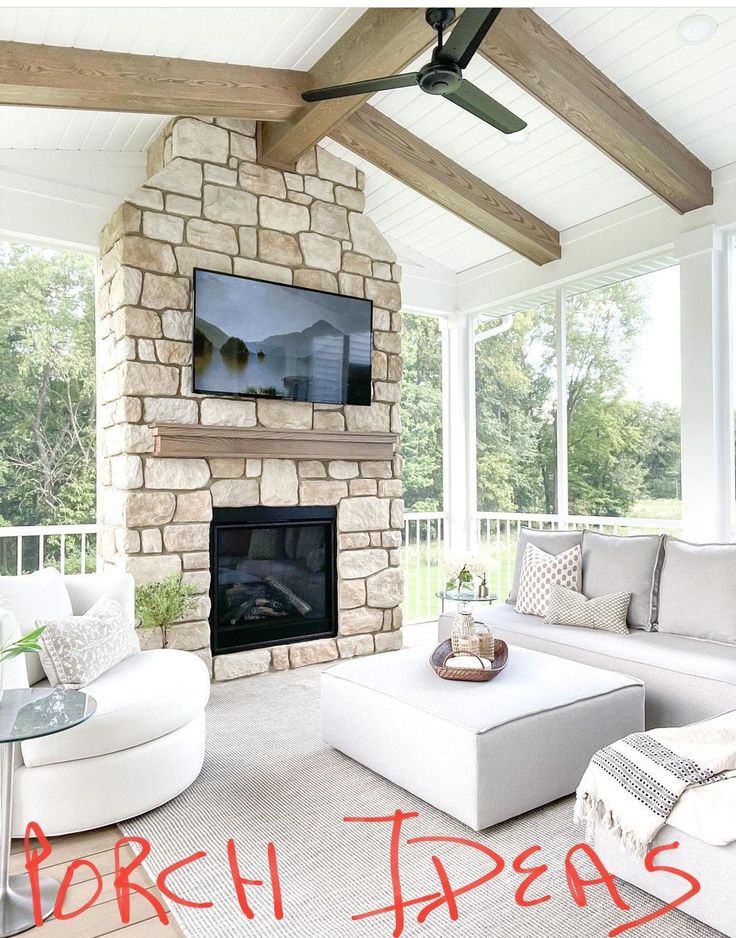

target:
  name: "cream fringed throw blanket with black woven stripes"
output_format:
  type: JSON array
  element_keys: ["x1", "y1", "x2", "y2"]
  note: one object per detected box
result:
[{"x1": 575, "y1": 711, "x2": 736, "y2": 856}]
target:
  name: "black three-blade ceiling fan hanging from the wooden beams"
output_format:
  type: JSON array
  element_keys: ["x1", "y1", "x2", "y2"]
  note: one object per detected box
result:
[{"x1": 302, "y1": 7, "x2": 526, "y2": 134}]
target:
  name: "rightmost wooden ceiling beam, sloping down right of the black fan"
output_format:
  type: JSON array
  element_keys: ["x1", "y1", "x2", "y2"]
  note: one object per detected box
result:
[{"x1": 479, "y1": 7, "x2": 713, "y2": 213}]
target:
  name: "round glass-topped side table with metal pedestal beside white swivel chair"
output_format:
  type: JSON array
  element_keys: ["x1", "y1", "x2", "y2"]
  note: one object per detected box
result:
[{"x1": 0, "y1": 687, "x2": 97, "y2": 938}]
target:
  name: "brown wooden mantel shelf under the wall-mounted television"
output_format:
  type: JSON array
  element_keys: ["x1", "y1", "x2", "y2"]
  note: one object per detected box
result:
[{"x1": 151, "y1": 423, "x2": 398, "y2": 459}]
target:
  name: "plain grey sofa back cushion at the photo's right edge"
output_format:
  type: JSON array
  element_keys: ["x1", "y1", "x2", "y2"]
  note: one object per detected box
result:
[{"x1": 658, "y1": 537, "x2": 736, "y2": 644}]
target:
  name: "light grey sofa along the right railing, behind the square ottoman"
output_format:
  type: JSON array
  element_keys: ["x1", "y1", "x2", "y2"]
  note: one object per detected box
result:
[{"x1": 438, "y1": 528, "x2": 736, "y2": 729}]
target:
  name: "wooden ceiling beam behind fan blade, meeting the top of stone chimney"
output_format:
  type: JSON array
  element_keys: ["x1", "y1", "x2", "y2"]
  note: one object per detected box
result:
[{"x1": 259, "y1": 8, "x2": 437, "y2": 169}]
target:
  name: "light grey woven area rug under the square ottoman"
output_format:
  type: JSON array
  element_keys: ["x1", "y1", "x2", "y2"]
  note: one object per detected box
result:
[{"x1": 121, "y1": 668, "x2": 719, "y2": 938}]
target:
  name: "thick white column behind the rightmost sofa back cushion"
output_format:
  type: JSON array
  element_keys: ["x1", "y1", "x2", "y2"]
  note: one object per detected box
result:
[{"x1": 675, "y1": 225, "x2": 734, "y2": 541}]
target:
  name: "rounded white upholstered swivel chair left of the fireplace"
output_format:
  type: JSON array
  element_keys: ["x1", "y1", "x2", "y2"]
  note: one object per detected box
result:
[{"x1": 0, "y1": 572, "x2": 210, "y2": 837}]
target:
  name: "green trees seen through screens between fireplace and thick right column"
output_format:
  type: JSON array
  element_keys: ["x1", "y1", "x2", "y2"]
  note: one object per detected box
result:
[{"x1": 401, "y1": 280, "x2": 680, "y2": 516}]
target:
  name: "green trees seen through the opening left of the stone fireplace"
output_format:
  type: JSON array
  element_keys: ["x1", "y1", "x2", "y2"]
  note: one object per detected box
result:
[{"x1": 0, "y1": 243, "x2": 95, "y2": 524}]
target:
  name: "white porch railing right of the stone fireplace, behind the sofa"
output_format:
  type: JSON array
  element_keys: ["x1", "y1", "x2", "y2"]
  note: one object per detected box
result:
[{"x1": 402, "y1": 511, "x2": 682, "y2": 622}]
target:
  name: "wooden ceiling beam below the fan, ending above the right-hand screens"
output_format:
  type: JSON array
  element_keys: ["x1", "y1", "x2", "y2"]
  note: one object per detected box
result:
[{"x1": 331, "y1": 104, "x2": 560, "y2": 264}]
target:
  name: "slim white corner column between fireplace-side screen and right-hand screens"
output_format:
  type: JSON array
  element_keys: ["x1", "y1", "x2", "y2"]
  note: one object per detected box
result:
[{"x1": 443, "y1": 316, "x2": 476, "y2": 552}]
